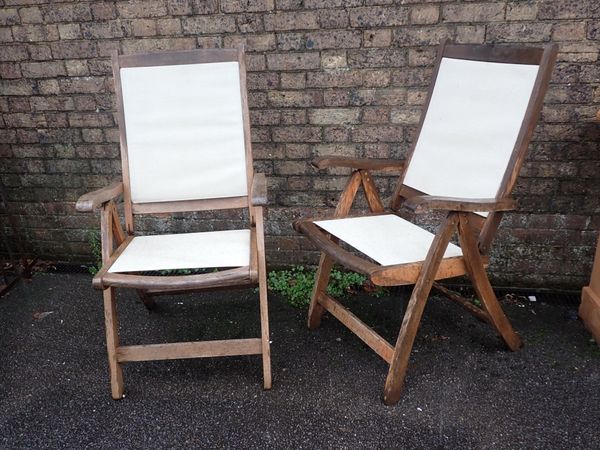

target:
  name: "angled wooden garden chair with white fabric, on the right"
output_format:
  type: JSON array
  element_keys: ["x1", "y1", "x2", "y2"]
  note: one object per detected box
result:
[{"x1": 294, "y1": 42, "x2": 558, "y2": 405}]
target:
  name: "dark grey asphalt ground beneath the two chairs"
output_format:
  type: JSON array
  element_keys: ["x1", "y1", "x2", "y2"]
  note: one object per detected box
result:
[{"x1": 0, "y1": 274, "x2": 600, "y2": 449}]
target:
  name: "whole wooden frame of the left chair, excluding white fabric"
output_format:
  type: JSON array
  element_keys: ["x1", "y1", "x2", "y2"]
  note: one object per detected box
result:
[{"x1": 76, "y1": 47, "x2": 271, "y2": 399}]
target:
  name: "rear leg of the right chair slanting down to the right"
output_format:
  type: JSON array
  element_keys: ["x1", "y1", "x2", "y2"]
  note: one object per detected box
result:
[{"x1": 459, "y1": 214, "x2": 523, "y2": 351}]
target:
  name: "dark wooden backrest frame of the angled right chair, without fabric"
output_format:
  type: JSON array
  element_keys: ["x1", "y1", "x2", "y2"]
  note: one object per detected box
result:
[{"x1": 391, "y1": 41, "x2": 558, "y2": 253}]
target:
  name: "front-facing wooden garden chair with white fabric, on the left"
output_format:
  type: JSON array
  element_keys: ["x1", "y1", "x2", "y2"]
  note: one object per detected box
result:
[{"x1": 76, "y1": 48, "x2": 271, "y2": 399}]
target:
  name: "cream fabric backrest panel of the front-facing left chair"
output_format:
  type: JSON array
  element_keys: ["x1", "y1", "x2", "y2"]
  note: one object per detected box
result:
[{"x1": 120, "y1": 62, "x2": 248, "y2": 203}]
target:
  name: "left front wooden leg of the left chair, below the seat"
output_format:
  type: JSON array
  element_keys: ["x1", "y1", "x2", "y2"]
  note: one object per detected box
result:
[{"x1": 103, "y1": 287, "x2": 124, "y2": 400}]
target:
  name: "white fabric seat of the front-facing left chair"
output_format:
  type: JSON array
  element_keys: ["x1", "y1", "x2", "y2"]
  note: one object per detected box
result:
[{"x1": 108, "y1": 230, "x2": 250, "y2": 273}]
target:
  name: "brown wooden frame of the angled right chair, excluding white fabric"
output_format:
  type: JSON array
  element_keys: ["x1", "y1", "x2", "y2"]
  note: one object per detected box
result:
[{"x1": 294, "y1": 42, "x2": 558, "y2": 405}]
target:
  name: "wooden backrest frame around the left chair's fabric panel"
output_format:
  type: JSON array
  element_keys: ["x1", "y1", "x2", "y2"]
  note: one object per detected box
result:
[{"x1": 112, "y1": 46, "x2": 254, "y2": 234}]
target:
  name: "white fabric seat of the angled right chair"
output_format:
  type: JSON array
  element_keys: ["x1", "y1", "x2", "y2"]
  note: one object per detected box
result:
[{"x1": 315, "y1": 214, "x2": 462, "y2": 266}]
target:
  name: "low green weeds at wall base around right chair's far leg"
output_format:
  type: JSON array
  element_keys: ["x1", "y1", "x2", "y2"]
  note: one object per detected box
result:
[{"x1": 267, "y1": 266, "x2": 388, "y2": 308}]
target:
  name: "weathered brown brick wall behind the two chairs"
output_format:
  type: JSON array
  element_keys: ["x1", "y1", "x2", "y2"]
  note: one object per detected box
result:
[{"x1": 0, "y1": 0, "x2": 600, "y2": 287}]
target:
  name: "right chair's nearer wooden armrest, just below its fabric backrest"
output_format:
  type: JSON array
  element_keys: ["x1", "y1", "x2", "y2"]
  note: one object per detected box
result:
[{"x1": 404, "y1": 195, "x2": 517, "y2": 213}]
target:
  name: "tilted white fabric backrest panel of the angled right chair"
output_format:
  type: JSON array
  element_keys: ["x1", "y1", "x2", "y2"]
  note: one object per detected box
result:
[{"x1": 404, "y1": 58, "x2": 539, "y2": 198}]
